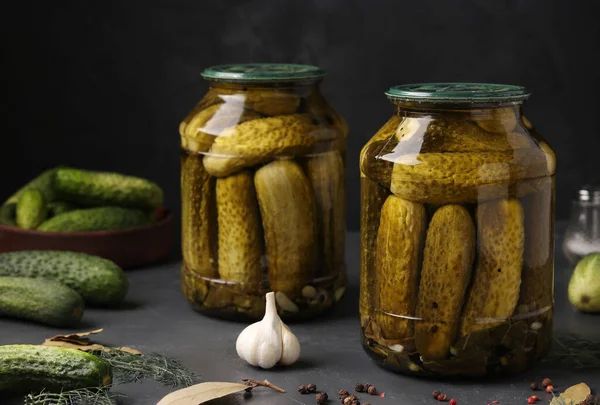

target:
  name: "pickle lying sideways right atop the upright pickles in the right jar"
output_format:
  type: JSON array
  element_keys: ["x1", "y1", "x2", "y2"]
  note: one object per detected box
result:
[{"x1": 390, "y1": 149, "x2": 547, "y2": 204}]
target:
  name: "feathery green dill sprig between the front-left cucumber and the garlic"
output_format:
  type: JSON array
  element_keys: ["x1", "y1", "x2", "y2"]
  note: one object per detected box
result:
[{"x1": 93, "y1": 350, "x2": 199, "y2": 388}]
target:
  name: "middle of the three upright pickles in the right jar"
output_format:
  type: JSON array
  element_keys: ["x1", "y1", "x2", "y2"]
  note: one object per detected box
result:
[{"x1": 415, "y1": 205, "x2": 476, "y2": 360}]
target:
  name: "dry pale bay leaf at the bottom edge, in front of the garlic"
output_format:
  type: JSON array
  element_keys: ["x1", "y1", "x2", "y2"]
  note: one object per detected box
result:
[{"x1": 156, "y1": 382, "x2": 248, "y2": 405}]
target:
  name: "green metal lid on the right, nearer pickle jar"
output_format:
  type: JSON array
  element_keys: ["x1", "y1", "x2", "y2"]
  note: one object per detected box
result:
[{"x1": 385, "y1": 83, "x2": 529, "y2": 104}]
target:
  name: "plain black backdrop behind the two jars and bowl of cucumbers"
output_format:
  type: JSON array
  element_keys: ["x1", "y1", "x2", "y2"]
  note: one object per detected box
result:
[{"x1": 0, "y1": 0, "x2": 600, "y2": 230}]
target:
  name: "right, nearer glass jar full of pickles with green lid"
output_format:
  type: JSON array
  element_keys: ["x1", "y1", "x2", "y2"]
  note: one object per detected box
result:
[{"x1": 360, "y1": 83, "x2": 556, "y2": 376}]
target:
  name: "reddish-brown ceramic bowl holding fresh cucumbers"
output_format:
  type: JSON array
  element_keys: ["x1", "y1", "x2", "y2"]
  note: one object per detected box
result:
[{"x1": 0, "y1": 208, "x2": 175, "y2": 269}]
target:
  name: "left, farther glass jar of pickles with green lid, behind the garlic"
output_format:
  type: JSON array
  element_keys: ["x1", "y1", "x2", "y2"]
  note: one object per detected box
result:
[{"x1": 179, "y1": 64, "x2": 347, "y2": 320}]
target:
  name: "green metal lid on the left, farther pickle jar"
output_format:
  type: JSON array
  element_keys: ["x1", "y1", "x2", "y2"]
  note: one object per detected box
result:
[{"x1": 202, "y1": 63, "x2": 325, "y2": 82}]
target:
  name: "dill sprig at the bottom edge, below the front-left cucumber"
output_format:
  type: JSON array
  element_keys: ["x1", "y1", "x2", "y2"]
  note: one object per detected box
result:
[{"x1": 24, "y1": 388, "x2": 117, "y2": 405}]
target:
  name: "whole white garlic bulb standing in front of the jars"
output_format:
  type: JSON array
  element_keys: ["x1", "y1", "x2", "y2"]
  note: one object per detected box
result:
[{"x1": 235, "y1": 292, "x2": 300, "y2": 368}]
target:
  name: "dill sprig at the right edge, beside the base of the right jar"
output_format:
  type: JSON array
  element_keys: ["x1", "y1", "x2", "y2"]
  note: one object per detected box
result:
[{"x1": 542, "y1": 334, "x2": 600, "y2": 369}]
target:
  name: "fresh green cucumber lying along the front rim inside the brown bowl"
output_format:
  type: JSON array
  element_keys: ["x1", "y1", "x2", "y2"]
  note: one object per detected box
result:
[{"x1": 38, "y1": 207, "x2": 150, "y2": 232}]
